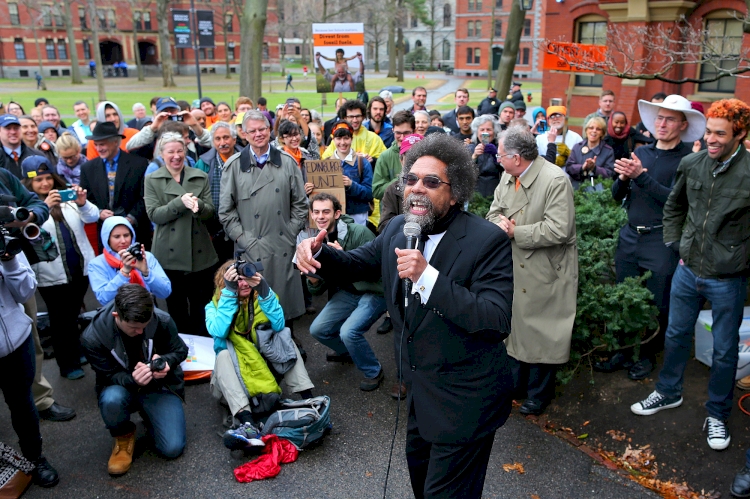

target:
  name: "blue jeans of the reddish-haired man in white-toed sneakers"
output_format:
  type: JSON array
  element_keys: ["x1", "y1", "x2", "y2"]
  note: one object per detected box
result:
[{"x1": 656, "y1": 265, "x2": 747, "y2": 421}]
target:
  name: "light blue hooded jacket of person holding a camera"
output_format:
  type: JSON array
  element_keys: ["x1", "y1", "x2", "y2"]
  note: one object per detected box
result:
[{"x1": 88, "y1": 216, "x2": 172, "y2": 305}]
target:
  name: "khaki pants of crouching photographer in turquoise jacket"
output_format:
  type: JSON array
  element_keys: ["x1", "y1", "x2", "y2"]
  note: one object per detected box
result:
[{"x1": 211, "y1": 345, "x2": 315, "y2": 416}]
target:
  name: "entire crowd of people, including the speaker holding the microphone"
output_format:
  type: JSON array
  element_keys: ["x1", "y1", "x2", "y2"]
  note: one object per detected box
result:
[{"x1": 0, "y1": 83, "x2": 750, "y2": 497}]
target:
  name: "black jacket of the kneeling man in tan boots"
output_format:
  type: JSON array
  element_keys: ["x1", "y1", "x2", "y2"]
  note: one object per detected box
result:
[{"x1": 81, "y1": 300, "x2": 188, "y2": 400}]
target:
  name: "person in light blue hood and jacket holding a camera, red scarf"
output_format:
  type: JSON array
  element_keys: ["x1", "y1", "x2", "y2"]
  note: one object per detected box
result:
[{"x1": 89, "y1": 216, "x2": 172, "y2": 305}]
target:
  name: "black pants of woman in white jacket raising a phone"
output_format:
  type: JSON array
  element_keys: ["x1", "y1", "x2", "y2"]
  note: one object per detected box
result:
[{"x1": 39, "y1": 274, "x2": 89, "y2": 376}]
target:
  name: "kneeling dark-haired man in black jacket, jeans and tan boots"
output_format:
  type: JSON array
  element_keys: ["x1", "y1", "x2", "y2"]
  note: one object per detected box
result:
[{"x1": 81, "y1": 284, "x2": 188, "y2": 475}]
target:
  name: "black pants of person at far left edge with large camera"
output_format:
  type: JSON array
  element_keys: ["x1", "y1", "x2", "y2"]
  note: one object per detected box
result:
[{"x1": 0, "y1": 333, "x2": 42, "y2": 461}]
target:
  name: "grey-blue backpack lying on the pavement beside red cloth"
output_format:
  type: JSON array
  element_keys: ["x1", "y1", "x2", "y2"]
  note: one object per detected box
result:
[{"x1": 260, "y1": 395, "x2": 333, "y2": 450}]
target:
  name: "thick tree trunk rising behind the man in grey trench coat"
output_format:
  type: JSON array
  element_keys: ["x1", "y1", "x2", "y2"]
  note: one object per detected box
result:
[{"x1": 240, "y1": 0, "x2": 270, "y2": 102}]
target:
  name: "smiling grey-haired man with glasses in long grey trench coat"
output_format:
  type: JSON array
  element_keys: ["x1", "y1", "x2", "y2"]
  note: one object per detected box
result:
[{"x1": 219, "y1": 111, "x2": 308, "y2": 325}]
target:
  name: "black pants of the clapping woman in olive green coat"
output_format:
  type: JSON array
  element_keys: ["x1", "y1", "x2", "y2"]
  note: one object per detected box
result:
[{"x1": 164, "y1": 265, "x2": 217, "y2": 336}]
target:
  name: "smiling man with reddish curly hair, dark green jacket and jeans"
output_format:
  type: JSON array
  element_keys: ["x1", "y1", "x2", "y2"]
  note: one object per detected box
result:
[{"x1": 630, "y1": 99, "x2": 750, "y2": 450}]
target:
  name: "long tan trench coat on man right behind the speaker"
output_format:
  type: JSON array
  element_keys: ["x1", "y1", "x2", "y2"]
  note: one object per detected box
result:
[{"x1": 487, "y1": 157, "x2": 578, "y2": 364}]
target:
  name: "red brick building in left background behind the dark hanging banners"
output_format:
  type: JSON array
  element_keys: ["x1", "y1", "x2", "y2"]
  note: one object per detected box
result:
[{"x1": 0, "y1": 0, "x2": 279, "y2": 78}]
